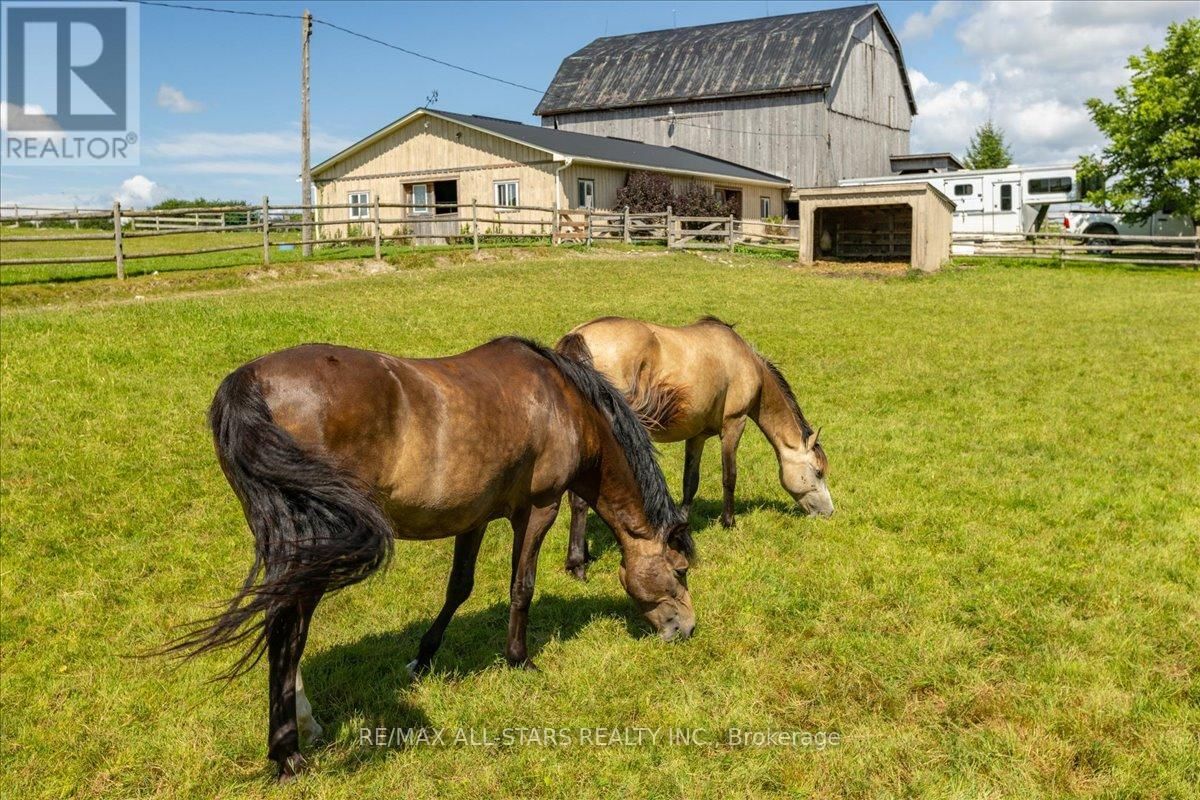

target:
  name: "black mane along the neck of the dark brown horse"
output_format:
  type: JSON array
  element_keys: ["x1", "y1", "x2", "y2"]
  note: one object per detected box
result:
[{"x1": 497, "y1": 336, "x2": 690, "y2": 546}]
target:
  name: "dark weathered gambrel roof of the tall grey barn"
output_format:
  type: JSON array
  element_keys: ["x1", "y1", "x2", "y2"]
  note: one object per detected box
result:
[{"x1": 534, "y1": 4, "x2": 917, "y2": 116}]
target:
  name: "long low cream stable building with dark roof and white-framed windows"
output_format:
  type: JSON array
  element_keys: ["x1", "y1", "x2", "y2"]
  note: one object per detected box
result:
[{"x1": 312, "y1": 108, "x2": 791, "y2": 236}]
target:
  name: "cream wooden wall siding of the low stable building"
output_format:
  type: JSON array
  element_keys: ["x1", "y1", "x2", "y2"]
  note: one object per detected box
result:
[{"x1": 316, "y1": 116, "x2": 786, "y2": 237}]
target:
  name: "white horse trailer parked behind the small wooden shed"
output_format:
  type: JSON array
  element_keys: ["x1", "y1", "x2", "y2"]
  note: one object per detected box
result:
[{"x1": 839, "y1": 164, "x2": 1080, "y2": 234}]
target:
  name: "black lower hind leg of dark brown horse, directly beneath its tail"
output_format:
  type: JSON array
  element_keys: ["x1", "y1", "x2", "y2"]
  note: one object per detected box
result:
[{"x1": 265, "y1": 599, "x2": 317, "y2": 782}]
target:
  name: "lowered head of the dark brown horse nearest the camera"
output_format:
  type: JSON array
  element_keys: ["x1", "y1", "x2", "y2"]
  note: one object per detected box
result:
[{"x1": 617, "y1": 519, "x2": 696, "y2": 642}]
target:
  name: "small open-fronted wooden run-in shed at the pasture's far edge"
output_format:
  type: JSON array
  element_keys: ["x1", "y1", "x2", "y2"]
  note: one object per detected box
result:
[{"x1": 791, "y1": 184, "x2": 954, "y2": 272}]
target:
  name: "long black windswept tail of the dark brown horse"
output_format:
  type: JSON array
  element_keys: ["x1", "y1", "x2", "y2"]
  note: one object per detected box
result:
[{"x1": 163, "y1": 367, "x2": 392, "y2": 679}]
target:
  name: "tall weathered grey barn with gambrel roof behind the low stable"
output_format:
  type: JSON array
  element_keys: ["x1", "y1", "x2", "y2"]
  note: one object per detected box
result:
[{"x1": 535, "y1": 4, "x2": 917, "y2": 199}]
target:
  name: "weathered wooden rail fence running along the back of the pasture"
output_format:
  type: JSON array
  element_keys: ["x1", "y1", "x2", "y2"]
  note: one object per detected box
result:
[{"x1": 0, "y1": 197, "x2": 1200, "y2": 278}]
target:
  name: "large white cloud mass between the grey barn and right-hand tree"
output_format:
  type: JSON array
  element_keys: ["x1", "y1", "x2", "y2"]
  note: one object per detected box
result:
[{"x1": 905, "y1": 0, "x2": 1195, "y2": 163}]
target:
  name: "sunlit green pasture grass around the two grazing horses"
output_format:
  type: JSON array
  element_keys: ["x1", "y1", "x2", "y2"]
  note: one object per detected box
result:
[{"x1": 0, "y1": 251, "x2": 1200, "y2": 799}]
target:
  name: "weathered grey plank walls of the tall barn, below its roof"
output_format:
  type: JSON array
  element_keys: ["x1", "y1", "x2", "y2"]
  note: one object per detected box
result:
[{"x1": 542, "y1": 14, "x2": 912, "y2": 187}]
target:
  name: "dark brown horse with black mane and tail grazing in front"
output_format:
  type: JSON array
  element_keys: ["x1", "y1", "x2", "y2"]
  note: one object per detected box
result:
[{"x1": 167, "y1": 338, "x2": 696, "y2": 781}]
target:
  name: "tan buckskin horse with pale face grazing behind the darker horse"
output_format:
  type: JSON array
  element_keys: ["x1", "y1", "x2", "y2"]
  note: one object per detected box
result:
[{"x1": 557, "y1": 317, "x2": 833, "y2": 579}]
